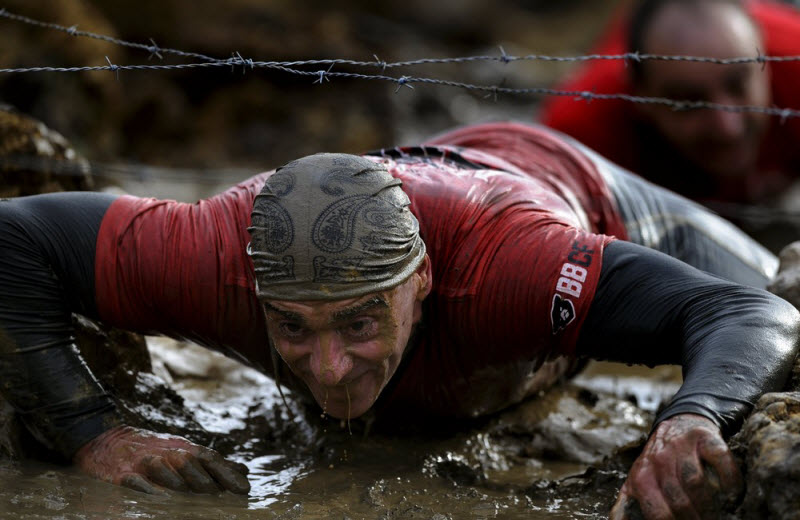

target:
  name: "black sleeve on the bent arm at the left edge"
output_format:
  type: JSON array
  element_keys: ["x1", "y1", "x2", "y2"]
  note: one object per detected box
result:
[{"x1": 0, "y1": 193, "x2": 118, "y2": 458}]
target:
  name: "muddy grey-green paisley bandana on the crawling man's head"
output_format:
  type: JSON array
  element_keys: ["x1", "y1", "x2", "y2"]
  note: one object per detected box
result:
[{"x1": 247, "y1": 153, "x2": 425, "y2": 301}]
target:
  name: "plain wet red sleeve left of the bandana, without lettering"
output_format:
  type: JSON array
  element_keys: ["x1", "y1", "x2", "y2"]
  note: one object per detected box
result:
[{"x1": 95, "y1": 174, "x2": 267, "y2": 359}]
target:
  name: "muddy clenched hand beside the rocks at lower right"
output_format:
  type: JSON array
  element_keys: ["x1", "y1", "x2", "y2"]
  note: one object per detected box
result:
[{"x1": 610, "y1": 414, "x2": 742, "y2": 520}]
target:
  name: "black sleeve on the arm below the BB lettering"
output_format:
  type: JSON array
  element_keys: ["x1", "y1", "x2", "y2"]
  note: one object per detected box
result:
[{"x1": 578, "y1": 241, "x2": 800, "y2": 435}]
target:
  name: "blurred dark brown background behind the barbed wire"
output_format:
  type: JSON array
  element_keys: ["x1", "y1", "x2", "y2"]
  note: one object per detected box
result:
[{"x1": 0, "y1": 0, "x2": 624, "y2": 200}]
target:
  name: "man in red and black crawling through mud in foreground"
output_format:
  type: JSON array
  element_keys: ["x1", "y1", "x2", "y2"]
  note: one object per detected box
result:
[{"x1": 0, "y1": 123, "x2": 800, "y2": 518}]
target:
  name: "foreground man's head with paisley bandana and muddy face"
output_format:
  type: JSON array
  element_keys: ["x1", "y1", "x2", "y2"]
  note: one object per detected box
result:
[{"x1": 248, "y1": 154, "x2": 432, "y2": 418}]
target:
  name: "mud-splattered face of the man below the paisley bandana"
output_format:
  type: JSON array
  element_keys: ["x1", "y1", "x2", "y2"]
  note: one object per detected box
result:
[{"x1": 264, "y1": 257, "x2": 430, "y2": 419}]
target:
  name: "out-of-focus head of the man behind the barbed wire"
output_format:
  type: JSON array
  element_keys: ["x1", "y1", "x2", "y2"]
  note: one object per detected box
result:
[{"x1": 628, "y1": 0, "x2": 771, "y2": 177}]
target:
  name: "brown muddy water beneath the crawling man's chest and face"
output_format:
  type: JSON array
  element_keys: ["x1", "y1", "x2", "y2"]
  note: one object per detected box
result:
[{"x1": 0, "y1": 342, "x2": 677, "y2": 520}]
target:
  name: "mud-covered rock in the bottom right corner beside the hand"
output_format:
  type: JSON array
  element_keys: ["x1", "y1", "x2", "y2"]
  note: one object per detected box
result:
[{"x1": 733, "y1": 392, "x2": 800, "y2": 520}]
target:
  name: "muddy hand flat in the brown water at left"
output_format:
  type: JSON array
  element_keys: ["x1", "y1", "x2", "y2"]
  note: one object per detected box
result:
[{"x1": 73, "y1": 426, "x2": 250, "y2": 494}]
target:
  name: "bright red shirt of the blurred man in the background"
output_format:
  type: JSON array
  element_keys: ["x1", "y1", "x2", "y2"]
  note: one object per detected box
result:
[{"x1": 537, "y1": 0, "x2": 800, "y2": 202}]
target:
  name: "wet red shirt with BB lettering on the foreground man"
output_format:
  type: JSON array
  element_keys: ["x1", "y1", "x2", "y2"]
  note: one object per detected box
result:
[{"x1": 96, "y1": 127, "x2": 624, "y2": 422}]
